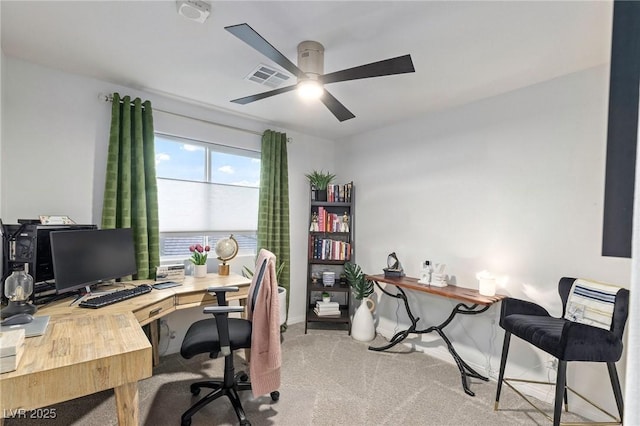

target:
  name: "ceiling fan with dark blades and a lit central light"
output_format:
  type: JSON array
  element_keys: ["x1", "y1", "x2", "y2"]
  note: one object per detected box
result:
[{"x1": 225, "y1": 24, "x2": 415, "y2": 121}]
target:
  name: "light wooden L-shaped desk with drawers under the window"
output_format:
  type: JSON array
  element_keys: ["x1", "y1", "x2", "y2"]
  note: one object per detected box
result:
[{"x1": 0, "y1": 274, "x2": 251, "y2": 425}]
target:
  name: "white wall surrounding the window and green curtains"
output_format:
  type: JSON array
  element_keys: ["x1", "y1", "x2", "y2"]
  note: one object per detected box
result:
[{"x1": 0, "y1": 57, "x2": 334, "y2": 349}]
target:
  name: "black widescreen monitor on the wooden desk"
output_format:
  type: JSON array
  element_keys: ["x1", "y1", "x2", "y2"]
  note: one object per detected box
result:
[{"x1": 50, "y1": 228, "x2": 137, "y2": 293}]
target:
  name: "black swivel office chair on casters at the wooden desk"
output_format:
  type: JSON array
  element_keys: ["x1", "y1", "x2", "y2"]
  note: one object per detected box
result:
[{"x1": 180, "y1": 255, "x2": 280, "y2": 426}]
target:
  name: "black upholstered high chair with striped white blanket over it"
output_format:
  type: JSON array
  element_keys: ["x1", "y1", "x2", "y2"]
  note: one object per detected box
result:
[{"x1": 495, "y1": 277, "x2": 629, "y2": 426}]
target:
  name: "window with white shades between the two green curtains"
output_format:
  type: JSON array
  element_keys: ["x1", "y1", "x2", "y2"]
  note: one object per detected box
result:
[{"x1": 155, "y1": 133, "x2": 260, "y2": 260}]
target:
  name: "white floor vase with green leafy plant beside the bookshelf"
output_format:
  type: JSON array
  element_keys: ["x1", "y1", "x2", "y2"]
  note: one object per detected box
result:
[{"x1": 344, "y1": 262, "x2": 376, "y2": 342}]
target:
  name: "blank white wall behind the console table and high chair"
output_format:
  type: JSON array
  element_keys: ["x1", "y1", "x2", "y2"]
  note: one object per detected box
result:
[{"x1": 337, "y1": 66, "x2": 631, "y2": 420}]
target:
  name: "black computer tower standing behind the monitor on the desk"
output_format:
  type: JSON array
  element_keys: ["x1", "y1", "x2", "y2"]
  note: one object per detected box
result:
[{"x1": 2, "y1": 220, "x2": 97, "y2": 303}]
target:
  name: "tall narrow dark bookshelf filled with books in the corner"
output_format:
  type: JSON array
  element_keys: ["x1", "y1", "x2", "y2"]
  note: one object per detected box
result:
[{"x1": 305, "y1": 182, "x2": 355, "y2": 333}]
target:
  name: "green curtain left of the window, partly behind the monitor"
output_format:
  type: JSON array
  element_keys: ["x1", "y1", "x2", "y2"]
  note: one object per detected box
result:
[{"x1": 102, "y1": 93, "x2": 160, "y2": 279}]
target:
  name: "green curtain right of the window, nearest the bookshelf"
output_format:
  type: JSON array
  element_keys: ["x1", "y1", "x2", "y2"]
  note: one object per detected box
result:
[{"x1": 258, "y1": 130, "x2": 290, "y2": 322}]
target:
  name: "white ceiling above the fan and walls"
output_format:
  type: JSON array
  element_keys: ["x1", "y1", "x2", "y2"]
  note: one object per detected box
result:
[{"x1": 0, "y1": 0, "x2": 612, "y2": 139}]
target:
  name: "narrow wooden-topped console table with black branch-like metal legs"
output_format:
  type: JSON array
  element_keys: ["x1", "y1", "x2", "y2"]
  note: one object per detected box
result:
[{"x1": 365, "y1": 275, "x2": 507, "y2": 396}]
